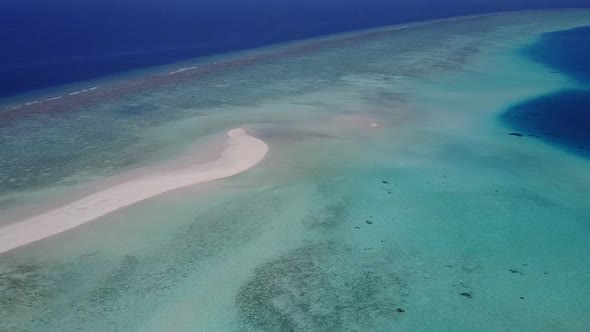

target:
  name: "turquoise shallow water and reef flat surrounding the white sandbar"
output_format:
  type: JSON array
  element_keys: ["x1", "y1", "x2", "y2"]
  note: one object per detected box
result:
[{"x1": 0, "y1": 11, "x2": 590, "y2": 331}]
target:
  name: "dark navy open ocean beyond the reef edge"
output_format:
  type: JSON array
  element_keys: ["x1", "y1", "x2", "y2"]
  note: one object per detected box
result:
[{"x1": 0, "y1": 0, "x2": 590, "y2": 97}]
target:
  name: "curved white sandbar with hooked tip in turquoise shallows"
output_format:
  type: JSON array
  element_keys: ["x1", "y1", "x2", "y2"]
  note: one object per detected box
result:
[{"x1": 0, "y1": 128, "x2": 268, "y2": 253}]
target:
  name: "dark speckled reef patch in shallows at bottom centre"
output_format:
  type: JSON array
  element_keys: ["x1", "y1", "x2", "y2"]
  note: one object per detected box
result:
[{"x1": 236, "y1": 242, "x2": 407, "y2": 331}]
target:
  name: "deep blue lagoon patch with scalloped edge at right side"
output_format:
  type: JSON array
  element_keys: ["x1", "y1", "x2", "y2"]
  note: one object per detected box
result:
[{"x1": 503, "y1": 27, "x2": 590, "y2": 158}]
